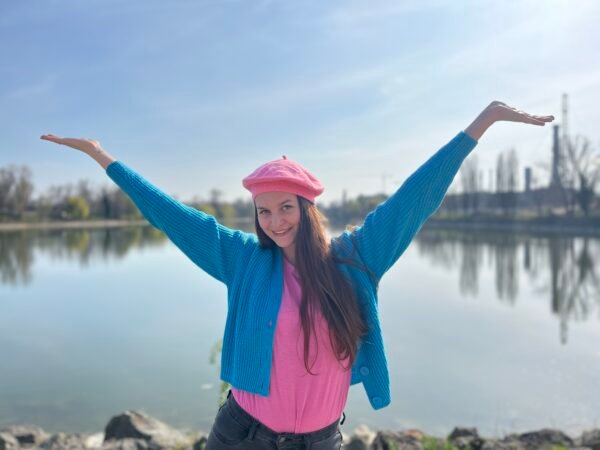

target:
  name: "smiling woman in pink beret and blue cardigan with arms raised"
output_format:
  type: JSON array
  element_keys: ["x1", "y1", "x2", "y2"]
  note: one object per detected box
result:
[{"x1": 41, "y1": 101, "x2": 554, "y2": 450}]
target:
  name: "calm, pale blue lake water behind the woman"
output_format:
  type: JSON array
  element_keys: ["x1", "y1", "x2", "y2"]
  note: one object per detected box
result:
[{"x1": 0, "y1": 227, "x2": 600, "y2": 436}]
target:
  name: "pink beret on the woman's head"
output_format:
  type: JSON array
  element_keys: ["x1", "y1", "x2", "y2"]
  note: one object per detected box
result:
[{"x1": 242, "y1": 155, "x2": 324, "y2": 203}]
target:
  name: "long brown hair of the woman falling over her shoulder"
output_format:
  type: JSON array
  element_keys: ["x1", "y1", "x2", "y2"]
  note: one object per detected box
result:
[{"x1": 254, "y1": 196, "x2": 368, "y2": 375}]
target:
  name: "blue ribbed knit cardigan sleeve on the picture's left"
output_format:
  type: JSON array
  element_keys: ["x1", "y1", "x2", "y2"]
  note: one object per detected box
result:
[{"x1": 106, "y1": 161, "x2": 257, "y2": 285}]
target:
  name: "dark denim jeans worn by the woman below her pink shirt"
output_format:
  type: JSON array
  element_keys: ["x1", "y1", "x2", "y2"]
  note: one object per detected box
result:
[{"x1": 205, "y1": 389, "x2": 346, "y2": 450}]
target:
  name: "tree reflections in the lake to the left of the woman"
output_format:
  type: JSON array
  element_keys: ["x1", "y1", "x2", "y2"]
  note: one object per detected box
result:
[{"x1": 0, "y1": 226, "x2": 166, "y2": 285}]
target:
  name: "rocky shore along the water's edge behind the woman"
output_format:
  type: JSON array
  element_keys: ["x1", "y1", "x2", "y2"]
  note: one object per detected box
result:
[{"x1": 0, "y1": 411, "x2": 600, "y2": 450}]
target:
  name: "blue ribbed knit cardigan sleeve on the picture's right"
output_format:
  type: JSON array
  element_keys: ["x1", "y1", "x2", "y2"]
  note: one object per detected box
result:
[{"x1": 346, "y1": 131, "x2": 477, "y2": 281}]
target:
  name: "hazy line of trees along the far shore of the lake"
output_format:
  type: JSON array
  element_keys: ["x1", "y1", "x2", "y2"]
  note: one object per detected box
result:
[{"x1": 0, "y1": 136, "x2": 600, "y2": 227}]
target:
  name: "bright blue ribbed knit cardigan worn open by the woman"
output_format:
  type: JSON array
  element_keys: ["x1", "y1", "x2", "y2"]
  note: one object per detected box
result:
[{"x1": 106, "y1": 131, "x2": 477, "y2": 409}]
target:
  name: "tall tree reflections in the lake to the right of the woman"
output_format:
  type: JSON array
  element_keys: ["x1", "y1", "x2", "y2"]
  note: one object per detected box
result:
[{"x1": 416, "y1": 230, "x2": 600, "y2": 343}]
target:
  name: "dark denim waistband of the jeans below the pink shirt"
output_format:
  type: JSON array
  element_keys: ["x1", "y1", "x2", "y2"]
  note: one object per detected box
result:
[{"x1": 226, "y1": 389, "x2": 346, "y2": 443}]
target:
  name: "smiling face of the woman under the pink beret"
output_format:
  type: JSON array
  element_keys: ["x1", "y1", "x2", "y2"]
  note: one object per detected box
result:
[{"x1": 254, "y1": 192, "x2": 300, "y2": 248}]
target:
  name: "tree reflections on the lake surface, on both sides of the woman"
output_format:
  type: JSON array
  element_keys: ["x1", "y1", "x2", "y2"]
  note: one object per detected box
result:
[{"x1": 0, "y1": 226, "x2": 600, "y2": 343}]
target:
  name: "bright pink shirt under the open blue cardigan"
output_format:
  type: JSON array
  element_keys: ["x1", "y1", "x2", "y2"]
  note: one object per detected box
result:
[{"x1": 231, "y1": 258, "x2": 352, "y2": 433}]
